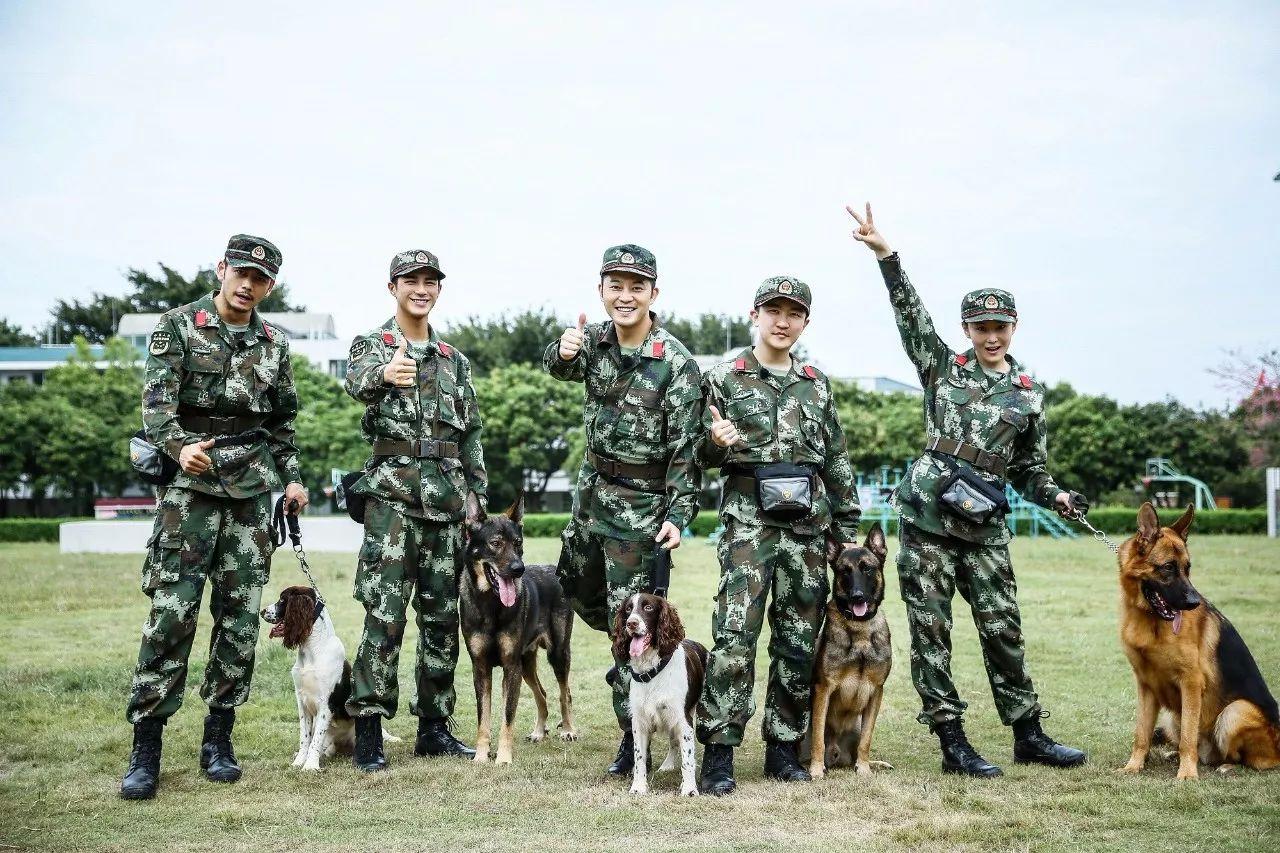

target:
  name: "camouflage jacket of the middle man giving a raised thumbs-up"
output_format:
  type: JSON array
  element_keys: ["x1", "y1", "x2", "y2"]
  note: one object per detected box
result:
[{"x1": 543, "y1": 314, "x2": 703, "y2": 540}]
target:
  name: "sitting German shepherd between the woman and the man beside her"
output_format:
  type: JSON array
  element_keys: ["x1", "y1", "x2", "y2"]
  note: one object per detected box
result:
[{"x1": 800, "y1": 521, "x2": 893, "y2": 779}]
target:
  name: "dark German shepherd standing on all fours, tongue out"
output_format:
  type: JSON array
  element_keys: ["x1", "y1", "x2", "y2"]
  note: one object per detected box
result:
[{"x1": 458, "y1": 493, "x2": 577, "y2": 765}]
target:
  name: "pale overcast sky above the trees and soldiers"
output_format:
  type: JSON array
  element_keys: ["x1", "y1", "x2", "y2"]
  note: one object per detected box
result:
[{"x1": 0, "y1": 1, "x2": 1280, "y2": 406}]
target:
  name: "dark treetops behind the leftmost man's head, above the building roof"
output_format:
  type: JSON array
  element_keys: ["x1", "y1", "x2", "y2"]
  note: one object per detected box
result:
[{"x1": 49, "y1": 264, "x2": 306, "y2": 343}]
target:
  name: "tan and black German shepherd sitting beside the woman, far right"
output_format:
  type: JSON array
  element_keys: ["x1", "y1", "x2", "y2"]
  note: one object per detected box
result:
[{"x1": 1119, "y1": 503, "x2": 1280, "y2": 779}]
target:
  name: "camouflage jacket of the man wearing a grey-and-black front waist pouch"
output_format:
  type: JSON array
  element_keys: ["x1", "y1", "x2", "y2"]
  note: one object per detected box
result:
[{"x1": 694, "y1": 347, "x2": 863, "y2": 542}]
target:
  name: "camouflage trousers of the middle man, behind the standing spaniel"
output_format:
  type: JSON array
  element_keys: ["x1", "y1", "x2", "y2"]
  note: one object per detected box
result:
[{"x1": 557, "y1": 521, "x2": 658, "y2": 731}]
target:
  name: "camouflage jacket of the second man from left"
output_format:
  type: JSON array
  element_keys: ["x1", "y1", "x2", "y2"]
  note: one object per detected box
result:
[{"x1": 346, "y1": 318, "x2": 489, "y2": 521}]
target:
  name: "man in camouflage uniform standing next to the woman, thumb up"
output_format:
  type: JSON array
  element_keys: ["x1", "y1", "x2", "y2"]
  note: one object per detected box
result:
[{"x1": 694, "y1": 277, "x2": 861, "y2": 794}]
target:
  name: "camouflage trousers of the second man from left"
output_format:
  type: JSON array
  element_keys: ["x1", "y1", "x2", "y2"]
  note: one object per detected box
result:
[{"x1": 347, "y1": 498, "x2": 462, "y2": 719}]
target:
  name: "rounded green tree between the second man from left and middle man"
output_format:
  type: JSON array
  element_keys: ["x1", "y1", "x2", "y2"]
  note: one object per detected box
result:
[{"x1": 475, "y1": 364, "x2": 582, "y2": 508}]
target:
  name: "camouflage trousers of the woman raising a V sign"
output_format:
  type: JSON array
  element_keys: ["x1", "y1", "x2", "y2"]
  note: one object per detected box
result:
[{"x1": 897, "y1": 524, "x2": 1039, "y2": 727}]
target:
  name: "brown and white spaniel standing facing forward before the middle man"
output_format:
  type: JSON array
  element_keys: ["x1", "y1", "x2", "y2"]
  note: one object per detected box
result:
[{"x1": 613, "y1": 593, "x2": 707, "y2": 797}]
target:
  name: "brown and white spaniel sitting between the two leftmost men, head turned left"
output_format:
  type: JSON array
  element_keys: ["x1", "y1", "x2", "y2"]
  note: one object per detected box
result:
[{"x1": 260, "y1": 587, "x2": 399, "y2": 770}]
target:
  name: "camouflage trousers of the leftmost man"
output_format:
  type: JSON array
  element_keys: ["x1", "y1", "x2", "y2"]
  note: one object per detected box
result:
[{"x1": 125, "y1": 488, "x2": 274, "y2": 722}]
